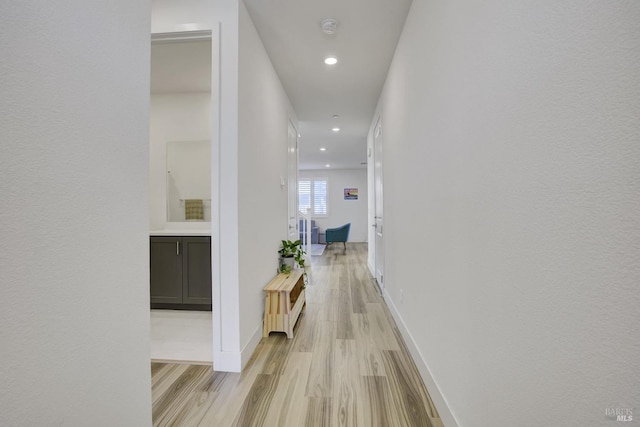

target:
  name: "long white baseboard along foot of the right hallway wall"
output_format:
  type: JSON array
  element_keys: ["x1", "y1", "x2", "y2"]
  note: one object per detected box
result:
[{"x1": 384, "y1": 290, "x2": 458, "y2": 427}]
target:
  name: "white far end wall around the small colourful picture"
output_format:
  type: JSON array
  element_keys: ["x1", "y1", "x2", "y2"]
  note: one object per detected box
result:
[{"x1": 299, "y1": 169, "x2": 369, "y2": 242}]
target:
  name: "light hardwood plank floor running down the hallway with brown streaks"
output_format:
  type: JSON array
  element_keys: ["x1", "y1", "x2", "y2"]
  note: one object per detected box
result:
[{"x1": 151, "y1": 243, "x2": 442, "y2": 427}]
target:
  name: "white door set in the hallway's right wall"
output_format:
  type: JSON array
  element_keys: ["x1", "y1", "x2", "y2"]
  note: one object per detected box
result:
[{"x1": 373, "y1": 117, "x2": 384, "y2": 289}]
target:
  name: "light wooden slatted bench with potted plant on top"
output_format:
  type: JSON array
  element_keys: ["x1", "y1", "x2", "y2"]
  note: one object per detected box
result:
[{"x1": 263, "y1": 270, "x2": 306, "y2": 339}]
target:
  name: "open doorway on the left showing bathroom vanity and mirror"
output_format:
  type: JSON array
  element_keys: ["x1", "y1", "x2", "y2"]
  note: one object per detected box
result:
[{"x1": 149, "y1": 31, "x2": 215, "y2": 364}]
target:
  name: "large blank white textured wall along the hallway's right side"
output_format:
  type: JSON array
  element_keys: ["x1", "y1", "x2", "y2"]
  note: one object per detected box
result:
[{"x1": 380, "y1": 0, "x2": 640, "y2": 427}]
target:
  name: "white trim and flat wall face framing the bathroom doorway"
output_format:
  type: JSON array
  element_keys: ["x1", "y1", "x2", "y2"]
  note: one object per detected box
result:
[{"x1": 151, "y1": 0, "x2": 241, "y2": 371}]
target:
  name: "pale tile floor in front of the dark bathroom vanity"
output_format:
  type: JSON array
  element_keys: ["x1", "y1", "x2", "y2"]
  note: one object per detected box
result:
[{"x1": 151, "y1": 310, "x2": 213, "y2": 364}]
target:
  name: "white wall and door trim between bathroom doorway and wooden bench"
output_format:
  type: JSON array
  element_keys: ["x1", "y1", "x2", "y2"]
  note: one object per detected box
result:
[{"x1": 152, "y1": 0, "x2": 296, "y2": 371}]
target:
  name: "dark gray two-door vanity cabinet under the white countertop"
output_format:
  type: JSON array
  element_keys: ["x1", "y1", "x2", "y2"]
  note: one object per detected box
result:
[{"x1": 150, "y1": 236, "x2": 211, "y2": 310}]
